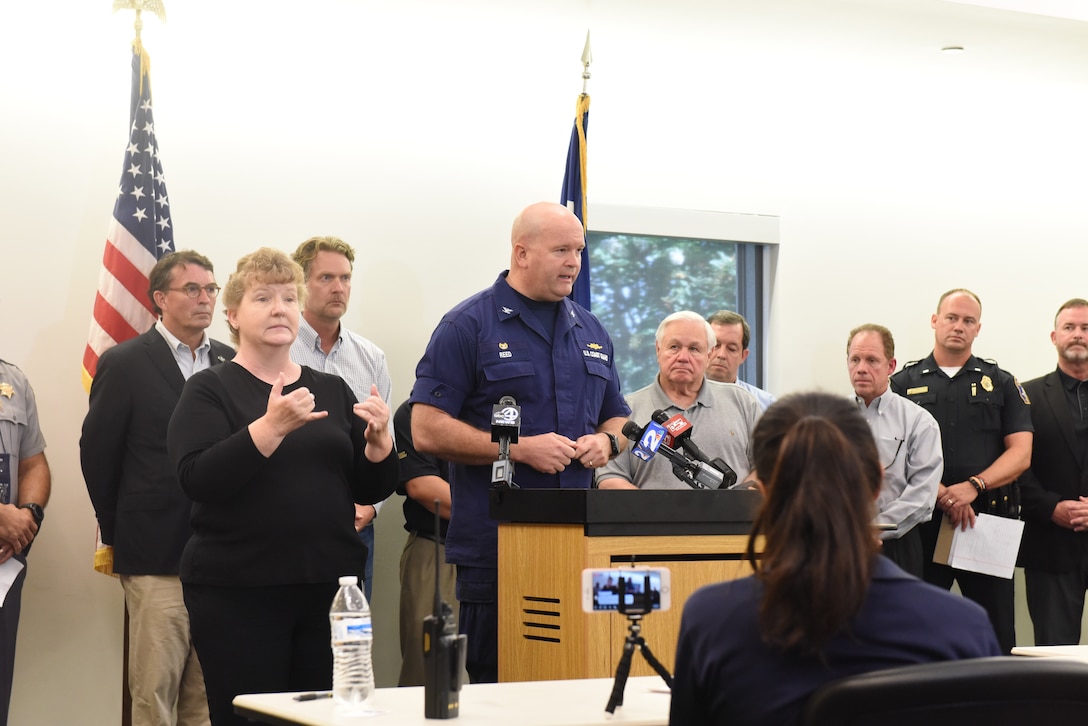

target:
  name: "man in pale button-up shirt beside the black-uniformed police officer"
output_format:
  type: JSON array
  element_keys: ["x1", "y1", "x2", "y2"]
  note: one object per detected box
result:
[{"x1": 846, "y1": 323, "x2": 944, "y2": 579}]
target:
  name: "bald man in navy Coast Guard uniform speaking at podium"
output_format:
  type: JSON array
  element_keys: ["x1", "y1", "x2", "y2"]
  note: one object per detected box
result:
[{"x1": 411, "y1": 202, "x2": 630, "y2": 682}]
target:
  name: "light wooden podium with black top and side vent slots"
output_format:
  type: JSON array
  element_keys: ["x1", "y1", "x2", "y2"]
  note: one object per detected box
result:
[{"x1": 491, "y1": 489, "x2": 759, "y2": 683}]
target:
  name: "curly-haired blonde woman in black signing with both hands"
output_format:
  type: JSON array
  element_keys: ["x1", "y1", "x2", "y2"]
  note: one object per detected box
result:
[{"x1": 168, "y1": 248, "x2": 398, "y2": 726}]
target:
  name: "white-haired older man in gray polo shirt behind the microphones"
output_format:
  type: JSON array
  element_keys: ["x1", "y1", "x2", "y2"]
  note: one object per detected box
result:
[{"x1": 597, "y1": 310, "x2": 762, "y2": 489}]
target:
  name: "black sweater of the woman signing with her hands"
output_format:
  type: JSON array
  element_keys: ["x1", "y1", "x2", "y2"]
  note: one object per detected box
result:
[{"x1": 166, "y1": 362, "x2": 397, "y2": 586}]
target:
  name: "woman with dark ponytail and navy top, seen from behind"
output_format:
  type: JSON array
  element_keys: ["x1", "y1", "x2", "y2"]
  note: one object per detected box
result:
[{"x1": 669, "y1": 393, "x2": 1001, "y2": 726}]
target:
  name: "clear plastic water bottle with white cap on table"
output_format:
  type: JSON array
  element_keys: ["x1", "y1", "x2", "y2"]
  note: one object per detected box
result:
[{"x1": 329, "y1": 575, "x2": 374, "y2": 711}]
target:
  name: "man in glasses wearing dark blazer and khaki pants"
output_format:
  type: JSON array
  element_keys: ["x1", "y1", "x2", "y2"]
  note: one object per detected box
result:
[{"x1": 79, "y1": 250, "x2": 234, "y2": 726}]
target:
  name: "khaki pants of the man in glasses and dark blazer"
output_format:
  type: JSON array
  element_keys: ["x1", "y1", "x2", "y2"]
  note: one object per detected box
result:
[{"x1": 121, "y1": 575, "x2": 211, "y2": 726}]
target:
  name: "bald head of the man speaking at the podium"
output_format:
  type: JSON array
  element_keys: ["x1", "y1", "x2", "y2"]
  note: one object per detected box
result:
[{"x1": 506, "y1": 201, "x2": 585, "y2": 303}]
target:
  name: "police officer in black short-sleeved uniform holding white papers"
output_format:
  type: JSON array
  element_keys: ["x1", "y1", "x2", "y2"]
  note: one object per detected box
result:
[{"x1": 891, "y1": 288, "x2": 1034, "y2": 651}]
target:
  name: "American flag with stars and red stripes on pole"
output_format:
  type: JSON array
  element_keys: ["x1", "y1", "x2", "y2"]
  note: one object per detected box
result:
[{"x1": 83, "y1": 45, "x2": 174, "y2": 392}]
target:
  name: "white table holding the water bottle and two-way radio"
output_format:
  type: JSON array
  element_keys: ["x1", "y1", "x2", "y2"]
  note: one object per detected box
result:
[{"x1": 234, "y1": 676, "x2": 670, "y2": 726}]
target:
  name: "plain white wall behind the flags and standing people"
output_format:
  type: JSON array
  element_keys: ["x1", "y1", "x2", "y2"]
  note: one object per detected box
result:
[{"x1": 0, "y1": 0, "x2": 1088, "y2": 725}]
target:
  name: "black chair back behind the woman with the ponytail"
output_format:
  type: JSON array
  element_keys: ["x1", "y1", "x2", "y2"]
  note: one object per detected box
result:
[{"x1": 801, "y1": 655, "x2": 1088, "y2": 726}]
